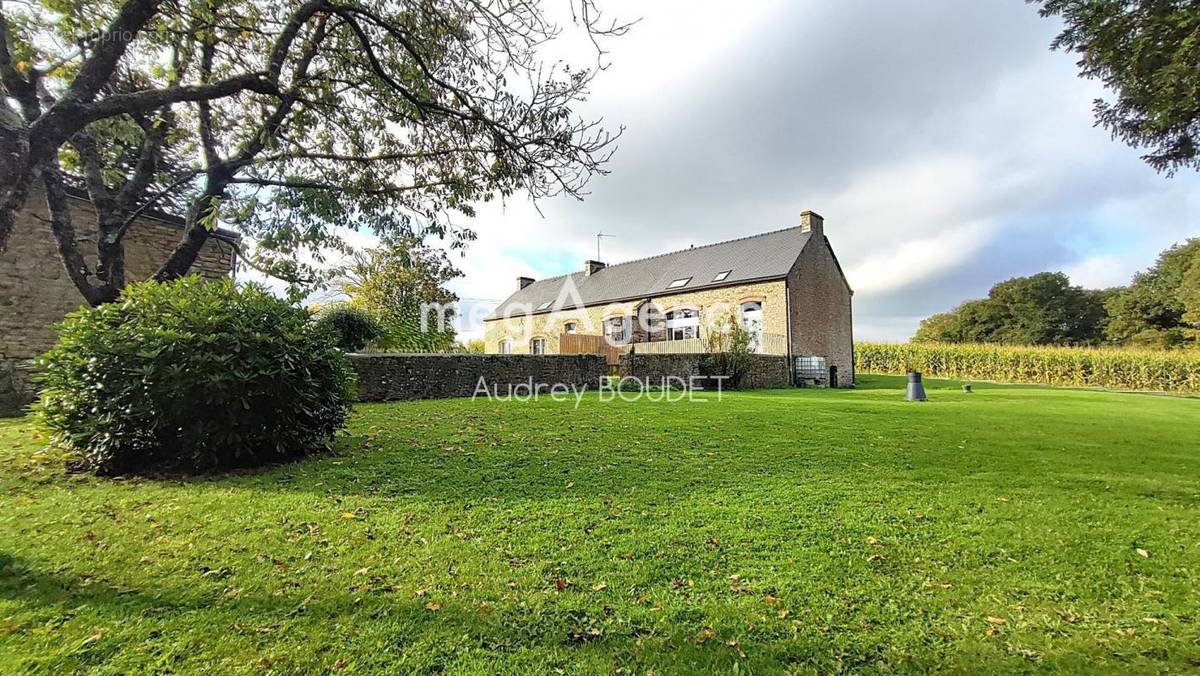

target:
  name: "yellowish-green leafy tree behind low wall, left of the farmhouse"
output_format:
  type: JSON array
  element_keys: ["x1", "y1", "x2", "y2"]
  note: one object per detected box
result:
[{"x1": 337, "y1": 238, "x2": 462, "y2": 352}]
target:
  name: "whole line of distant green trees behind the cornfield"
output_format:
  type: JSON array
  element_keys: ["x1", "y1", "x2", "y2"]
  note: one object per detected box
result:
[{"x1": 912, "y1": 238, "x2": 1200, "y2": 349}]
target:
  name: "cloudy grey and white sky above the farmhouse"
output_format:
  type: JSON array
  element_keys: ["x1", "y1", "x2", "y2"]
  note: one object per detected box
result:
[{"x1": 439, "y1": 0, "x2": 1200, "y2": 340}]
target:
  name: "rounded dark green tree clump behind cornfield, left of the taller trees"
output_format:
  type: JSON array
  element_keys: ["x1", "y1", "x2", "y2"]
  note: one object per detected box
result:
[{"x1": 913, "y1": 273, "x2": 1110, "y2": 345}]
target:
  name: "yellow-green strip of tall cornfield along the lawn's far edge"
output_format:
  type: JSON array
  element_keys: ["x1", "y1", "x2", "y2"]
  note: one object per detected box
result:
[{"x1": 854, "y1": 342, "x2": 1200, "y2": 391}]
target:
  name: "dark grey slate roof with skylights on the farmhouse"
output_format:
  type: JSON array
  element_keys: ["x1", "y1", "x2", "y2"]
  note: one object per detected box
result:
[{"x1": 487, "y1": 227, "x2": 811, "y2": 319}]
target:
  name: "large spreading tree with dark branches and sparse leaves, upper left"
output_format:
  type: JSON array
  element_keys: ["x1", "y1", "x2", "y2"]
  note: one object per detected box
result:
[{"x1": 0, "y1": 0, "x2": 626, "y2": 304}]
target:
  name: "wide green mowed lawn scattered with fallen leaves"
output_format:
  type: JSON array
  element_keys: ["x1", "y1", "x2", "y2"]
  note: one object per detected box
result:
[{"x1": 0, "y1": 377, "x2": 1200, "y2": 674}]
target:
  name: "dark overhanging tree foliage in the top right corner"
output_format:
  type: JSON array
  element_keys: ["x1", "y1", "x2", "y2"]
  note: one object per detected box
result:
[{"x1": 1030, "y1": 0, "x2": 1200, "y2": 174}]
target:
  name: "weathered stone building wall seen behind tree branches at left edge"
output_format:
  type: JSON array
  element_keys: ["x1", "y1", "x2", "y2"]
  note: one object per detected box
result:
[{"x1": 0, "y1": 193, "x2": 235, "y2": 414}]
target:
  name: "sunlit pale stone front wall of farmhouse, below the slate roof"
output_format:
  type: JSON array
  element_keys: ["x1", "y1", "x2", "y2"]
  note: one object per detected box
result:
[{"x1": 484, "y1": 280, "x2": 787, "y2": 354}]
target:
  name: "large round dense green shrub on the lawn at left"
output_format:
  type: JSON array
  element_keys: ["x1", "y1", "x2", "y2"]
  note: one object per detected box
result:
[{"x1": 38, "y1": 276, "x2": 353, "y2": 474}]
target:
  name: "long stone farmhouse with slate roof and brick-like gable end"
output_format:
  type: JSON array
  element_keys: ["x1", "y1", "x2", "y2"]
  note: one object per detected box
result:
[{"x1": 484, "y1": 211, "x2": 854, "y2": 387}]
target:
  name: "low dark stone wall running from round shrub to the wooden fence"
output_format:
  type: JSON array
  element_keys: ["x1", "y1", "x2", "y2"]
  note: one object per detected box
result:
[{"x1": 350, "y1": 354, "x2": 607, "y2": 401}]
